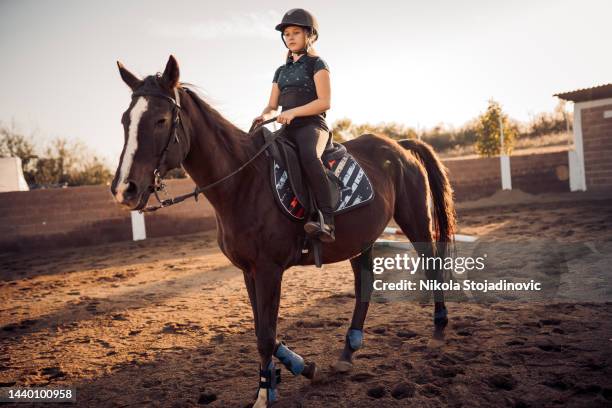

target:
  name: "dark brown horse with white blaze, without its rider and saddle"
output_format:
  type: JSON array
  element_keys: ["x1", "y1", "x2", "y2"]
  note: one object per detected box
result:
[{"x1": 111, "y1": 56, "x2": 455, "y2": 406}]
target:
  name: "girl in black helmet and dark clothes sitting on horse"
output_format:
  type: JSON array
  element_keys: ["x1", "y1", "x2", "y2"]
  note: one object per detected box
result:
[{"x1": 253, "y1": 9, "x2": 335, "y2": 242}]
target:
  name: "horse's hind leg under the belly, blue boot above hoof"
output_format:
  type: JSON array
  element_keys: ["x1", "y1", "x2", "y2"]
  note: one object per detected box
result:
[{"x1": 332, "y1": 246, "x2": 373, "y2": 373}]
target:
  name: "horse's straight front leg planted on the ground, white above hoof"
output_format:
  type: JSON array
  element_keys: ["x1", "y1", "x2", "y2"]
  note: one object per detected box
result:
[{"x1": 247, "y1": 263, "x2": 283, "y2": 408}]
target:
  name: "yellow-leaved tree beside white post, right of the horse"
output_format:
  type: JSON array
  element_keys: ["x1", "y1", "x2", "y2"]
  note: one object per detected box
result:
[{"x1": 476, "y1": 100, "x2": 518, "y2": 157}]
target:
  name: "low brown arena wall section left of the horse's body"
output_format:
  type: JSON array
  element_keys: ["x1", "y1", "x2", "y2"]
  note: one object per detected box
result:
[{"x1": 0, "y1": 180, "x2": 215, "y2": 252}]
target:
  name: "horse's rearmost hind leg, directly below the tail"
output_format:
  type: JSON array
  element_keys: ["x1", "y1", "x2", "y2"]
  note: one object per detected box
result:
[{"x1": 394, "y1": 185, "x2": 448, "y2": 340}]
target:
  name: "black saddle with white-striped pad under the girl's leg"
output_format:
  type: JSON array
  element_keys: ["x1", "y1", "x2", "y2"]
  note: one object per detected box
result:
[{"x1": 262, "y1": 127, "x2": 374, "y2": 267}]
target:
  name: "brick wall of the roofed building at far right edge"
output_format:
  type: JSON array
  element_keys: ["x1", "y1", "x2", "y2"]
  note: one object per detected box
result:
[{"x1": 581, "y1": 104, "x2": 612, "y2": 191}]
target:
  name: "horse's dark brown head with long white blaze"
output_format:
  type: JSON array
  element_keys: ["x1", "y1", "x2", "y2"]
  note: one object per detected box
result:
[{"x1": 111, "y1": 56, "x2": 189, "y2": 210}]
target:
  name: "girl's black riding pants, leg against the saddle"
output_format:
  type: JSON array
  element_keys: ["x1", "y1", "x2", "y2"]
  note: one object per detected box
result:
[{"x1": 287, "y1": 123, "x2": 334, "y2": 219}]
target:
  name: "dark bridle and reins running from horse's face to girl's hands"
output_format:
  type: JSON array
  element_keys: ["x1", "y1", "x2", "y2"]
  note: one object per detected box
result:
[{"x1": 132, "y1": 83, "x2": 285, "y2": 213}]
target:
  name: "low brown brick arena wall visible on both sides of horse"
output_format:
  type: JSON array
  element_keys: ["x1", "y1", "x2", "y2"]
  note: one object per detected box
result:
[{"x1": 0, "y1": 151, "x2": 569, "y2": 252}]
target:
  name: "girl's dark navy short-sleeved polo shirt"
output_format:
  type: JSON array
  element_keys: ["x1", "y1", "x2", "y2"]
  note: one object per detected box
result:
[{"x1": 272, "y1": 54, "x2": 329, "y2": 130}]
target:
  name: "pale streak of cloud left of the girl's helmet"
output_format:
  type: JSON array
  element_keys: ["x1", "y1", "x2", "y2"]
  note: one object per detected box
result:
[{"x1": 150, "y1": 10, "x2": 282, "y2": 40}]
